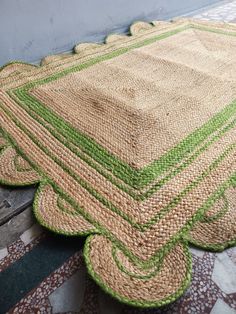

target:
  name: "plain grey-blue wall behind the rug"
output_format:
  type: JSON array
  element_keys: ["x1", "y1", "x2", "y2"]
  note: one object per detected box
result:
[{"x1": 0, "y1": 0, "x2": 221, "y2": 65}]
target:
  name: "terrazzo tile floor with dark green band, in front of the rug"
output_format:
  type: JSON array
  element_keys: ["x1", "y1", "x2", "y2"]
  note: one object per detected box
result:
[{"x1": 0, "y1": 224, "x2": 236, "y2": 314}]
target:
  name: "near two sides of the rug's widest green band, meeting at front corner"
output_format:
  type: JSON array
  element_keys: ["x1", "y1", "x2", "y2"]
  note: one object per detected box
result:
[{"x1": 11, "y1": 90, "x2": 236, "y2": 189}]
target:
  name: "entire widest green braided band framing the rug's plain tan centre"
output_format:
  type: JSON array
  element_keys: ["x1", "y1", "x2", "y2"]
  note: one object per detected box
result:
[{"x1": 9, "y1": 26, "x2": 236, "y2": 189}]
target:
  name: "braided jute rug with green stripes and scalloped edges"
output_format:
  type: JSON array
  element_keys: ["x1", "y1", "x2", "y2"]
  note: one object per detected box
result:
[{"x1": 0, "y1": 19, "x2": 236, "y2": 307}]
